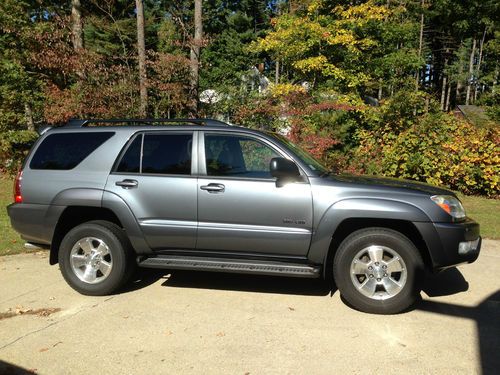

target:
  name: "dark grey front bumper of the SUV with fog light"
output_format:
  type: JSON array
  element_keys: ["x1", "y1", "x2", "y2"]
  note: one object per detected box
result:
[{"x1": 415, "y1": 218, "x2": 481, "y2": 269}]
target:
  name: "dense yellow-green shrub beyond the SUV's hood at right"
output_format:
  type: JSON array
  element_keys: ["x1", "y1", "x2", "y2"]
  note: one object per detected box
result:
[{"x1": 351, "y1": 113, "x2": 500, "y2": 196}]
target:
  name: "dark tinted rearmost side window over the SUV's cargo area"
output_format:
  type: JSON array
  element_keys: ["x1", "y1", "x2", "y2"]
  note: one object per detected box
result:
[{"x1": 30, "y1": 132, "x2": 115, "y2": 170}]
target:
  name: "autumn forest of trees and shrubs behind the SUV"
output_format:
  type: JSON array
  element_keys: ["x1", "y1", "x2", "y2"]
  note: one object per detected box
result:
[{"x1": 0, "y1": 0, "x2": 500, "y2": 198}]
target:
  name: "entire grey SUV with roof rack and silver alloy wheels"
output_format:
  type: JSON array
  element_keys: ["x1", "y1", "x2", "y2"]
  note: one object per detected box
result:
[{"x1": 4, "y1": 119, "x2": 481, "y2": 314}]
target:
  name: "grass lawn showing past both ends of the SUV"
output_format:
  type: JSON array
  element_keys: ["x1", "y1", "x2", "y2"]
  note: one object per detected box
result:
[{"x1": 0, "y1": 175, "x2": 500, "y2": 255}]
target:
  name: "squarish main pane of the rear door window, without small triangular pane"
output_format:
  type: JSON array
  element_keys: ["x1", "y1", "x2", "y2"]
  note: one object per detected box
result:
[{"x1": 142, "y1": 134, "x2": 193, "y2": 174}]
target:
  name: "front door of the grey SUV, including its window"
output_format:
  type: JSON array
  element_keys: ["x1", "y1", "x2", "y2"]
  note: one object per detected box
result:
[{"x1": 197, "y1": 132, "x2": 312, "y2": 256}]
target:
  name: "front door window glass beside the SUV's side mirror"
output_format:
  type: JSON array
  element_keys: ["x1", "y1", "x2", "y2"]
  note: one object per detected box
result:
[{"x1": 205, "y1": 135, "x2": 280, "y2": 178}]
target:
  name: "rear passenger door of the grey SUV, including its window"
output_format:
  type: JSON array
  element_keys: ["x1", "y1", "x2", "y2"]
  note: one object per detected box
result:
[{"x1": 106, "y1": 131, "x2": 197, "y2": 250}]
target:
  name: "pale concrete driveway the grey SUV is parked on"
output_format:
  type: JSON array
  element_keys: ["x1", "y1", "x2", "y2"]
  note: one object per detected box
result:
[{"x1": 0, "y1": 241, "x2": 500, "y2": 375}]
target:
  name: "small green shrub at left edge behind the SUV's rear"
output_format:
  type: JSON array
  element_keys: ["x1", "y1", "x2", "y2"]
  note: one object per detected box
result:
[{"x1": 0, "y1": 130, "x2": 38, "y2": 173}]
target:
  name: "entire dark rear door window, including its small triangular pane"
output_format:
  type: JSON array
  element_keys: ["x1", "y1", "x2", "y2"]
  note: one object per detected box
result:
[{"x1": 116, "y1": 134, "x2": 193, "y2": 175}]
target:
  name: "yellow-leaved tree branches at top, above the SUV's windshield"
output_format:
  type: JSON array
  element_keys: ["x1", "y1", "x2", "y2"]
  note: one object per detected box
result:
[{"x1": 252, "y1": 0, "x2": 390, "y2": 90}]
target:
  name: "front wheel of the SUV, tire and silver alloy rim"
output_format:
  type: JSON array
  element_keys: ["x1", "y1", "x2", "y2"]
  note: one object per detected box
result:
[{"x1": 333, "y1": 228, "x2": 424, "y2": 314}]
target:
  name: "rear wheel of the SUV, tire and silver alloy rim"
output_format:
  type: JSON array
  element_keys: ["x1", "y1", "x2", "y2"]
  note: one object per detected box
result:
[{"x1": 58, "y1": 220, "x2": 134, "y2": 296}]
